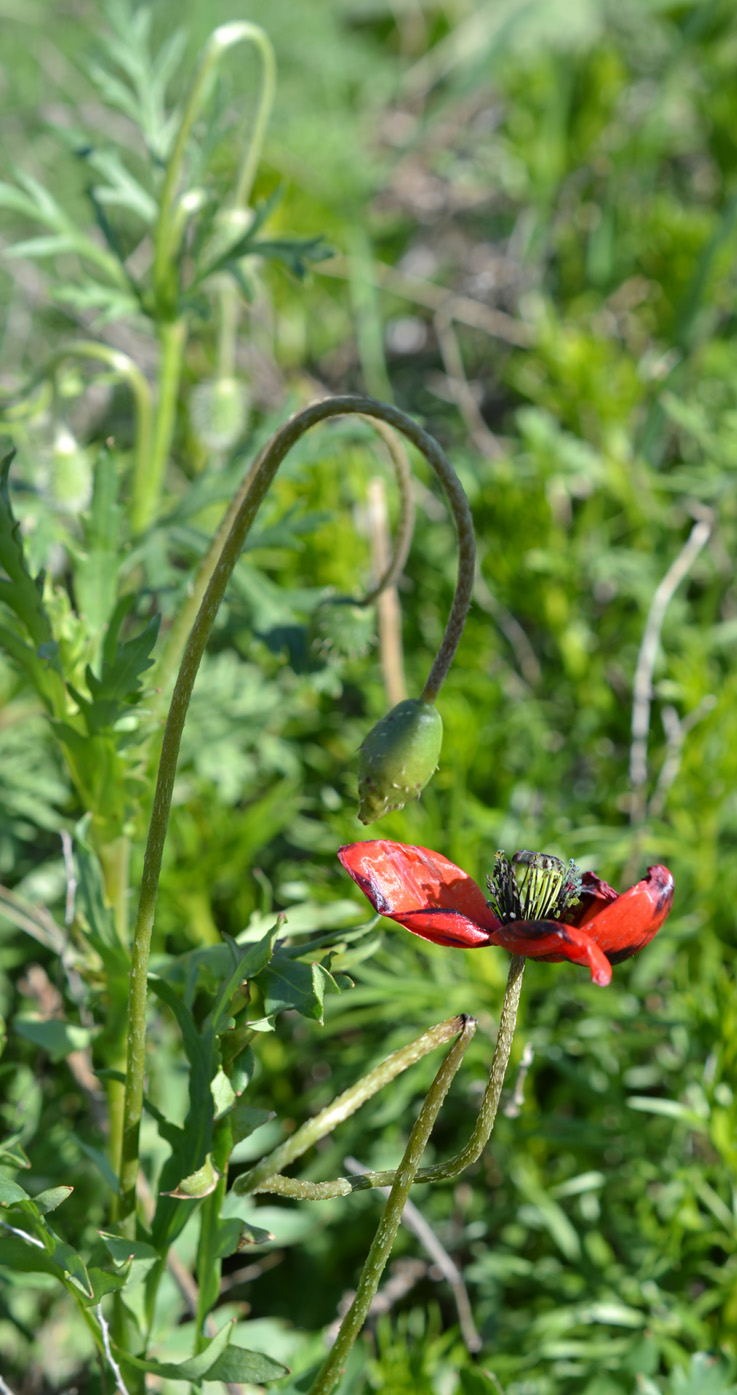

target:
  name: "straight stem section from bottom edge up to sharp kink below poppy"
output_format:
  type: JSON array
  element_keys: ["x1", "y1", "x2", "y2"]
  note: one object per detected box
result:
[{"x1": 310, "y1": 1017, "x2": 476, "y2": 1395}]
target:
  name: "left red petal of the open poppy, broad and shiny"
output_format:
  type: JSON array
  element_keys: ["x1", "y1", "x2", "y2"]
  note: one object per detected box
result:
[{"x1": 338, "y1": 838, "x2": 500, "y2": 949}]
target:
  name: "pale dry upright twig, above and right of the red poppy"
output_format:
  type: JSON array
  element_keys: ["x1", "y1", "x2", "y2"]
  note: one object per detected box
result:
[{"x1": 630, "y1": 518, "x2": 713, "y2": 824}]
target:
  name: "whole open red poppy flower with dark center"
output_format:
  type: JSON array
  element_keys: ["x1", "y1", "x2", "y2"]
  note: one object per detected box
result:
[{"x1": 338, "y1": 838, "x2": 673, "y2": 986}]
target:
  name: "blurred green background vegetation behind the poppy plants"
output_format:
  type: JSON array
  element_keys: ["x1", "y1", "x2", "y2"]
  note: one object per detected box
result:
[{"x1": 0, "y1": 0, "x2": 737, "y2": 1395}]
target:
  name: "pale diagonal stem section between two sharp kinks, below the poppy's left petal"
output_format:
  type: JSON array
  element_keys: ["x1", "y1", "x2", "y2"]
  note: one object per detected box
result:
[{"x1": 233, "y1": 1017, "x2": 465, "y2": 1196}]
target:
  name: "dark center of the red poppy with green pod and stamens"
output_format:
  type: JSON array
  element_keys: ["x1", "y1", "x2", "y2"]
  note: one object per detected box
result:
[{"x1": 486, "y1": 848, "x2": 581, "y2": 923}]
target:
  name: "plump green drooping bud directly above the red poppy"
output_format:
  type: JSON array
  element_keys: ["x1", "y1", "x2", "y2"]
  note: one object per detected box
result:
[{"x1": 359, "y1": 698, "x2": 442, "y2": 823}]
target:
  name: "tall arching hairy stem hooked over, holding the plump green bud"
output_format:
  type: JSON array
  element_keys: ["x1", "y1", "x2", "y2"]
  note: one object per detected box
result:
[{"x1": 120, "y1": 398, "x2": 476, "y2": 1235}]
